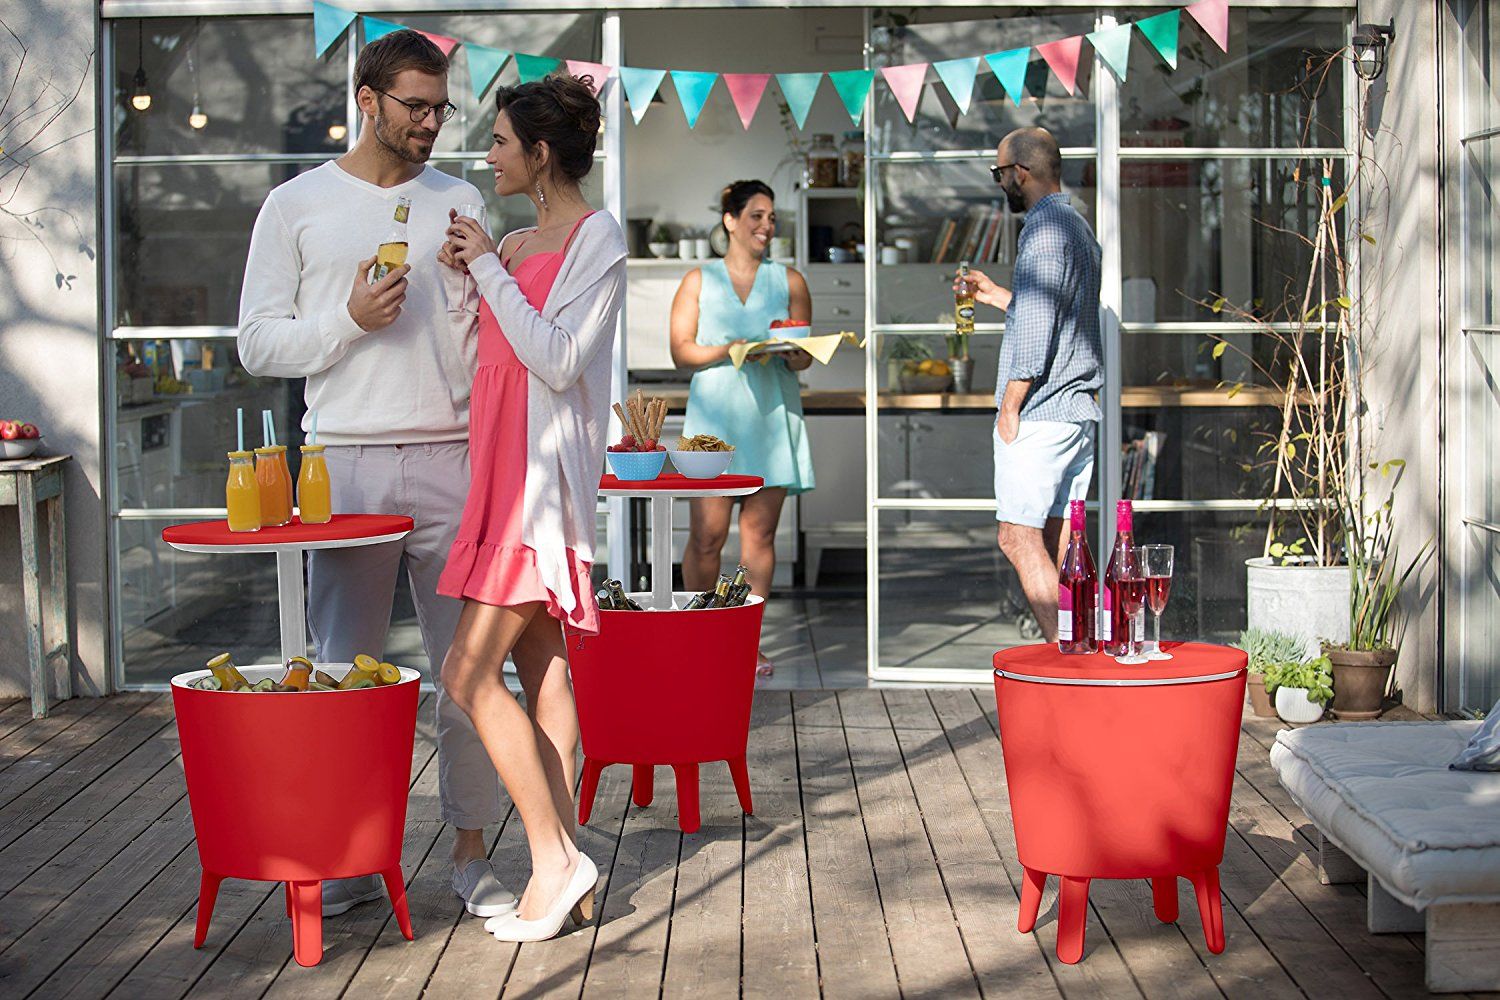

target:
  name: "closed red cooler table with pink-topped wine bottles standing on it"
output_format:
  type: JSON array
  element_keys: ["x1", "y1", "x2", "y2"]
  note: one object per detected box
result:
[{"x1": 995, "y1": 643, "x2": 1247, "y2": 964}]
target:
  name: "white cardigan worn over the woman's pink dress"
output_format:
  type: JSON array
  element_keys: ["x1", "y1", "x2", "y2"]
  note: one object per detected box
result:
[{"x1": 470, "y1": 211, "x2": 626, "y2": 613}]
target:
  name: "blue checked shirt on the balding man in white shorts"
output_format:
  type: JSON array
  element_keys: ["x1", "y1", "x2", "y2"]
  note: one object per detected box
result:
[{"x1": 995, "y1": 193, "x2": 1103, "y2": 421}]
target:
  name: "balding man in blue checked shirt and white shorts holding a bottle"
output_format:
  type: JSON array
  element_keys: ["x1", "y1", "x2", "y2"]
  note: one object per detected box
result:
[{"x1": 954, "y1": 127, "x2": 1103, "y2": 642}]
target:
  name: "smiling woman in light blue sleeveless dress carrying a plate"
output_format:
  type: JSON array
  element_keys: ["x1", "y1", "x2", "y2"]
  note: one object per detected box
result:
[{"x1": 672, "y1": 180, "x2": 813, "y2": 675}]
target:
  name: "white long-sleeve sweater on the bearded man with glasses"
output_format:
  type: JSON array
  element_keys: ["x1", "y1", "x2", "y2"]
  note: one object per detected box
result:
[{"x1": 239, "y1": 162, "x2": 483, "y2": 445}]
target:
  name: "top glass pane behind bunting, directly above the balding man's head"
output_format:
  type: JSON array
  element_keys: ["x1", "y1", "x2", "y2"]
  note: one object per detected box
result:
[{"x1": 870, "y1": 7, "x2": 1095, "y2": 153}]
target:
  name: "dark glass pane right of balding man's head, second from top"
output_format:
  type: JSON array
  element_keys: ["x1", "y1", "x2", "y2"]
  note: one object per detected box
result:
[{"x1": 1121, "y1": 159, "x2": 1344, "y2": 322}]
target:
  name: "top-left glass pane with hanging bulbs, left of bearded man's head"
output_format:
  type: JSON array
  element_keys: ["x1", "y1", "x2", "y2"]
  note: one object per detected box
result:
[{"x1": 111, "y1": 16, "x2": 348, "y2": 156}]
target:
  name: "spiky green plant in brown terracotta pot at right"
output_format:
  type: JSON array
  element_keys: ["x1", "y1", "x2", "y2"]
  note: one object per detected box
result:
[{"x1": 1323, "y1": 459, "x2": 1431, "y2": 720}]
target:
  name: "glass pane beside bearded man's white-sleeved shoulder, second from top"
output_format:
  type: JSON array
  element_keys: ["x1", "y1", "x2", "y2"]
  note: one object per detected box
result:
[{"x1": 114, "y1": 163, "x2": 325, "y2": 327}]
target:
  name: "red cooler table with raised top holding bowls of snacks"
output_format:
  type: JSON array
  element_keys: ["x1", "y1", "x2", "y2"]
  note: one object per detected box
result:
[{"x1": 569, "y1": 474, "x2": 765, "y2": 834}]
